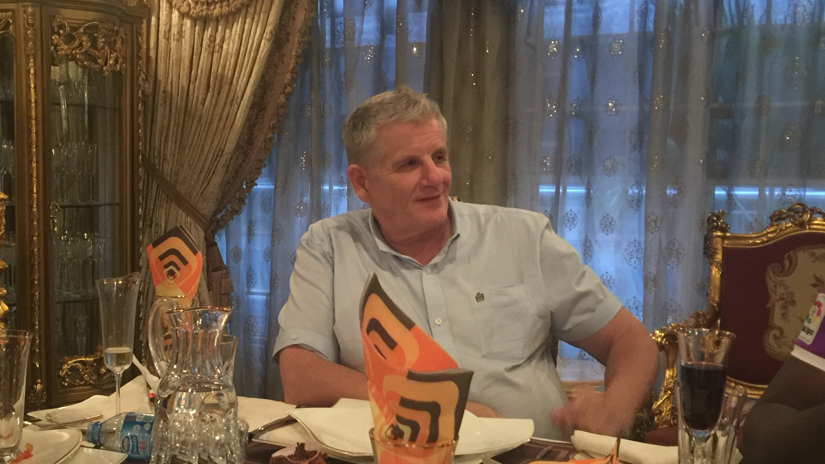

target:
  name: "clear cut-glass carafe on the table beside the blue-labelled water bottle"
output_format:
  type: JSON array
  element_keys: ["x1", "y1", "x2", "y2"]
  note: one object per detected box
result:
[{"x1": 152, "y1": 307, "x2": 243, "y2": 464}]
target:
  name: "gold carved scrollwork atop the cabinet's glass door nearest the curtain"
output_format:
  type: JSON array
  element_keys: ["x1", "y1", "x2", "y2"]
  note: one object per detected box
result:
[{"x1": 52, "y1": 15, "x2": 126, "y2": 75}]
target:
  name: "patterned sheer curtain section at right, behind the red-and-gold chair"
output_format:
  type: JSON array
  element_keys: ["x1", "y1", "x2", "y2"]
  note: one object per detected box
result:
[{"x1": 642, "y1": 0, "x2": 825, "y2": 334}]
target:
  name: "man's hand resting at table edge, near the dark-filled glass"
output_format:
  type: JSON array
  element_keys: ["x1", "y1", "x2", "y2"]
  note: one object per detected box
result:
[{"x1": 550, "y1": 388, "x2": 633, "y2": 437}]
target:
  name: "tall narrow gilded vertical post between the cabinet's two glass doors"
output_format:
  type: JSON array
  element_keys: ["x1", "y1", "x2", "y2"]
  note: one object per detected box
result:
[{"x1": 23, "y1": 5, "x2": 46, "y2": 407}]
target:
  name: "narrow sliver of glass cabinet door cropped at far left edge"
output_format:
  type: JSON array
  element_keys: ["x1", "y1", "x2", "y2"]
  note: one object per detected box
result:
[{"x1": 0, "y1": 10, "x2": 20, "y2": 328}]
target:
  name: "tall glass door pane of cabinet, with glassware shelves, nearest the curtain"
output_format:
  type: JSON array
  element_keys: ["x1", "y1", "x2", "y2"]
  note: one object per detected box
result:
[{"x1": 48, "y1": 57, "x2": 124, "y2": 366}]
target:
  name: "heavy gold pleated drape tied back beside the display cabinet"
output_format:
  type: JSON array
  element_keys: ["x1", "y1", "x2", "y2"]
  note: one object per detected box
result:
[{"x1": 139, "y1": 0, "x2": 315, "y2": 320}]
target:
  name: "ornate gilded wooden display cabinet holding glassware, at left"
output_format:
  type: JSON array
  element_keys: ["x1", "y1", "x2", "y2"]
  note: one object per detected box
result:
[{"x1": 0, "y1": 0, "x2": 148, "y2": 408}]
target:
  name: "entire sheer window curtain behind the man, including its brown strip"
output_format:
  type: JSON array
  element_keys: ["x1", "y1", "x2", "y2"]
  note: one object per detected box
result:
[{"x1": 219, "y1": 0, "x2": 825, "y2": 397}]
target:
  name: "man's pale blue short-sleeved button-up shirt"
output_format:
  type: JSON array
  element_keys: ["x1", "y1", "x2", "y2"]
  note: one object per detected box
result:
[{"x1": 274, "y1": 202, "x2": 622, "y2": 438}]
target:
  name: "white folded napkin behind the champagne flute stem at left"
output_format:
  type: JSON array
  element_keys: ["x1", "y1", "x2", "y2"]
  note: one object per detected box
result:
[{"x1": 29, "y1": 376, "x2": 154, "y2": 428}]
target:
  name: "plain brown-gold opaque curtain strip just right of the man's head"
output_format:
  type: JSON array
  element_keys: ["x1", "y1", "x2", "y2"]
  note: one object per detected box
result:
[{"x1": 426, "y1": 0, "x2": 515, "y2": 206}]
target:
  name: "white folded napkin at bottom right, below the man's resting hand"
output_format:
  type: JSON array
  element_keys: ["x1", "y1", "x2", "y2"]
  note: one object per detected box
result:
[{"x1": 571, "y1": 430, "x2": 679, "y2": 464}]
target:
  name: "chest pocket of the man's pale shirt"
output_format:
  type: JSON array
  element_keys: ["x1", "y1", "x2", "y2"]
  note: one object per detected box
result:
[{"x1": 470, "y1": 285, "x2": 548, "y2": 362}]
